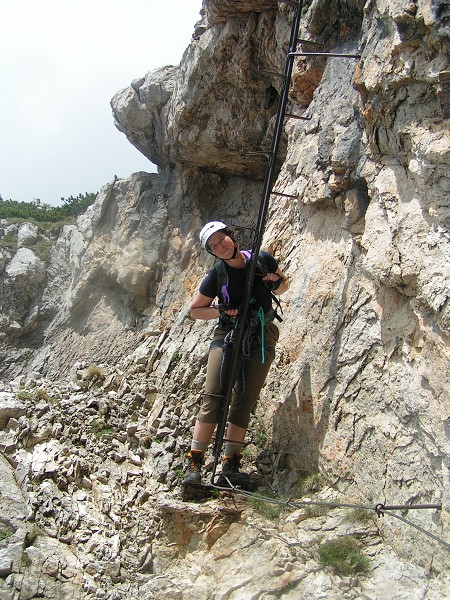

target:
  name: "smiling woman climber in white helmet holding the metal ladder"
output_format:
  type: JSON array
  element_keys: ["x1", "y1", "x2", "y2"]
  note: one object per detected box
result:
[{"x1": 183, "y1": 221, "x2": 289, "y2": 488}]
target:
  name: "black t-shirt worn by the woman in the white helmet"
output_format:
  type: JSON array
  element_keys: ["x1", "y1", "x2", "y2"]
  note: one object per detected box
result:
[{"x1": 199, "y1": 251, "x2": 278, "y2": 312}]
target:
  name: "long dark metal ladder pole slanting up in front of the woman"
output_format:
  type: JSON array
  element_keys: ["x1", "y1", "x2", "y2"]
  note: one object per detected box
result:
[{"x1": 211, "y1": 0, "x2": 303, "y2": 484}]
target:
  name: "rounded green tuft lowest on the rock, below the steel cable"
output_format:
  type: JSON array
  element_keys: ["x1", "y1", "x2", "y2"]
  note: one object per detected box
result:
[{"x1": 318, "y1": 535, "x2": 370, "y2": 575}]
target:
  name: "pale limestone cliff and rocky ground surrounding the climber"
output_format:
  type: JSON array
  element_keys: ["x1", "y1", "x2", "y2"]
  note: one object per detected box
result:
[{"x1": 0, "y1": 0, "x2": 450, "y2": 600}]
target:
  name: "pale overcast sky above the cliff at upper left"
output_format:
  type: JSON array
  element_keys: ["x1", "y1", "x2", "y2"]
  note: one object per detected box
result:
[{"x1": 0, "y1": 0, "x2": 202, "y2": 204}]
